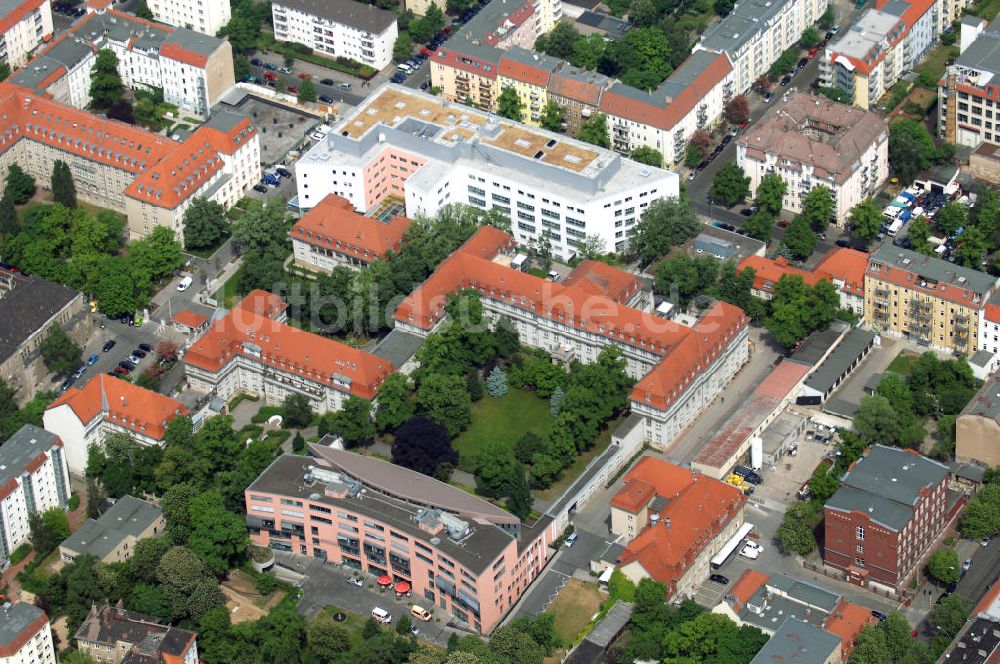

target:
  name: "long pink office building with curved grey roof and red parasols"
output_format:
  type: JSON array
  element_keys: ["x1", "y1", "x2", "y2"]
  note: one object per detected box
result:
[{"x1": 245, "y1": 442, "x2": 558, "y2": 634}]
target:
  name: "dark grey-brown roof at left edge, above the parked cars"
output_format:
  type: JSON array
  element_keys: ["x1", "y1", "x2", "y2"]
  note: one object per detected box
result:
[{"x1": 0, "y1": 277, "x2": 80, "y2": 362}]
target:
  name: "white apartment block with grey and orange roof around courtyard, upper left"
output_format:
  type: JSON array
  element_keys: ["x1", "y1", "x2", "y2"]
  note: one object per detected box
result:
[{"x1": 11, "y1": 10, "x2": 236, "y2": 118}]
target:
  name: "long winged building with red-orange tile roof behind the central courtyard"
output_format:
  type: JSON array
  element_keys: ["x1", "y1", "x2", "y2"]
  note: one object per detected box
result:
[{"x1": 396, "y1": 227, "x2": 749, "y2": 446}]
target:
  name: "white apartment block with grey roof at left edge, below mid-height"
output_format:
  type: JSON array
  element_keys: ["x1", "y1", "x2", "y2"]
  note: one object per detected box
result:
[{"x1": 0, "y1": 424, "x2": 70, "y2": 568}]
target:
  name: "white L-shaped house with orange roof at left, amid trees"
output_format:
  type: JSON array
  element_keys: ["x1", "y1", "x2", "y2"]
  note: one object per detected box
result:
[{"x1": 42, "y1": 374, "x2": 188, "y2": 475}]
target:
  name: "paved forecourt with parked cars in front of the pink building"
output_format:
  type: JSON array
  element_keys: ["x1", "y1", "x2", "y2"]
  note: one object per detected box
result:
[{"x1": 288, "y1": 554, "x2": 467, "y2": 647}]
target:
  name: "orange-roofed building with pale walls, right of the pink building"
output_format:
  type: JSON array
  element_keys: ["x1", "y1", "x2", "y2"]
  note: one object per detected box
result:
[{"x1": 611, "y1": 456, "x2": 747, "y2": 596}]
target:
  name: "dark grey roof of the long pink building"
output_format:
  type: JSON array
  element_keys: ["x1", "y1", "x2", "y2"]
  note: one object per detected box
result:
[{"x1": 247, "y1": 452, "x2": 520, "y2": 573}]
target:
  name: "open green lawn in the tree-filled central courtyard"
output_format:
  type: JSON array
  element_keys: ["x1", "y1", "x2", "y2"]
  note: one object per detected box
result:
[{"x1": 453, "y1": 388, "x2": 553, "y2": 473}]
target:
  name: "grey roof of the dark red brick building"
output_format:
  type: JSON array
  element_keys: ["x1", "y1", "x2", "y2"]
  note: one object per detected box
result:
[{"x1": 826, "y1": 445, "x2": 948, "y2": 532}]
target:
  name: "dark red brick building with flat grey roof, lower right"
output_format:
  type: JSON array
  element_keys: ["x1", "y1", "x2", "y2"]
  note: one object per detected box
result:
[{"x1": 823, "y1": 445, "x2": 956, "y2": 592}]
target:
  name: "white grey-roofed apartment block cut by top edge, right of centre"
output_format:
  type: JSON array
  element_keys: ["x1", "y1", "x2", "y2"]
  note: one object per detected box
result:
[{"x1": 695, "y1": 0, "x2": 827, "y2": 94}]
